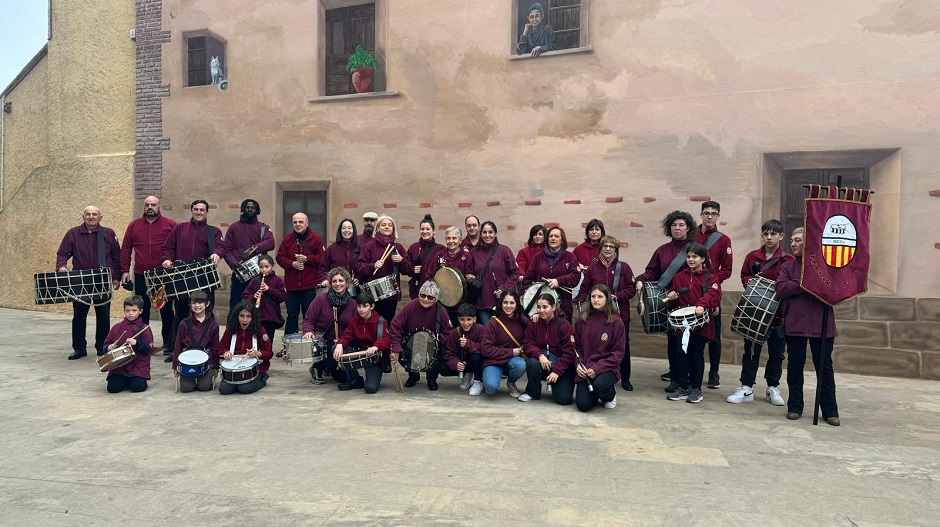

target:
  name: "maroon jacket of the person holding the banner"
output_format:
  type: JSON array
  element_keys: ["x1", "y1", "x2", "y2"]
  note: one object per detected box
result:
[{"x1": 777, "y1": 257, "x2": 838, "y2": 338}]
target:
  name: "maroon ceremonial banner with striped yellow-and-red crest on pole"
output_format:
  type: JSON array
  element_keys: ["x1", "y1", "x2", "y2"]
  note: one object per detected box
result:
[{"x1": 800, "y1": 185, "x2": 871, "y2": 306}]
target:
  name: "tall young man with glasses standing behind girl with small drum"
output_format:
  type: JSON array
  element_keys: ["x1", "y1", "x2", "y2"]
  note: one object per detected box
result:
[{"x1": 694, "y1": 201, "x2": 734, "y2": 389}]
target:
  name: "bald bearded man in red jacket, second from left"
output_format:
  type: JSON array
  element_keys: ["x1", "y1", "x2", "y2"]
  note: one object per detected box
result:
[{"x1": 121, "y1": 196, "x2": 176, "y2": 361}]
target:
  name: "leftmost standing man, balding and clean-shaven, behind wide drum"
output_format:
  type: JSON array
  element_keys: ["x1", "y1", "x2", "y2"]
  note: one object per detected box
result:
[{"x1": 55, "y1": 205, "x2": 121, "y2": 360}]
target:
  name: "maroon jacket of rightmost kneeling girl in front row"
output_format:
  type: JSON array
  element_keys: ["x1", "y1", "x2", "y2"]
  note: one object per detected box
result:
[{"x1": 574, "y1": 311, "x2": 627, "y2": 382}]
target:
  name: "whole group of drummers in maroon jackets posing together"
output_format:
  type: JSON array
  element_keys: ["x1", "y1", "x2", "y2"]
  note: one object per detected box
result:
[{"x1": 57, "y1": 196, "x2": 839, "y2": 426}]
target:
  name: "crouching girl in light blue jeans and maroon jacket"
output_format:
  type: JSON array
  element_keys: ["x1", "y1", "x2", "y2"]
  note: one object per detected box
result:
[{"x1": 480, "y1": 288, "x2": 529, "y2": 399}]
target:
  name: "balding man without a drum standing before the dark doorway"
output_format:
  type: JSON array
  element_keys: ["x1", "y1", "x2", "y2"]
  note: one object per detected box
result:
[{"x1": 277, "y1": 212, "x2": 326, "y2": 335}]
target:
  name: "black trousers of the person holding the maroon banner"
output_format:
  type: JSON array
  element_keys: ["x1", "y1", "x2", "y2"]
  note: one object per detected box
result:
[{"x1": 787, "y1": 335, "x2": 839, "y2": 419}]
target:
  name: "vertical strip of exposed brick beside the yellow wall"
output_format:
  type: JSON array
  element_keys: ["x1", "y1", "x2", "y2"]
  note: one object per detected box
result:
[{"x1": 134, "y1": 0, "x2": 170, "y2": 198}]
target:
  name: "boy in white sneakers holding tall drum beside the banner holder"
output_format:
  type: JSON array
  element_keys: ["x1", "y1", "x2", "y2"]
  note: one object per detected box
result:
[{"x1": 726, "y1": 220, "x2": 793, "y2": 406}]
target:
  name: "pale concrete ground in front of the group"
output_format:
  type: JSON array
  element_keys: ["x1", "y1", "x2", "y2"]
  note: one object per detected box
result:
[{"x1": 0, "y1": 310, "x2": 940, "y2": 527}]
